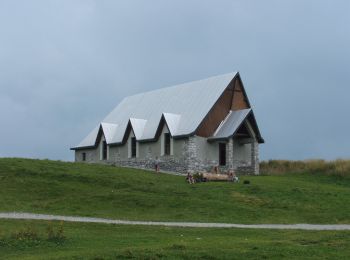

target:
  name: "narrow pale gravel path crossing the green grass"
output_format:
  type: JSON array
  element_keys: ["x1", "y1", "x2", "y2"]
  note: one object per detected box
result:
[{"x1": 0, "y1": 212, "x2": 350, "y2": 230}]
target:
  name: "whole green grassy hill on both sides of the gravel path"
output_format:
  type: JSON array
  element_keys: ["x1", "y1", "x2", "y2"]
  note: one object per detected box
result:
[{"x1": 0, "y1": 159, "x2": 350, "y2": 260}]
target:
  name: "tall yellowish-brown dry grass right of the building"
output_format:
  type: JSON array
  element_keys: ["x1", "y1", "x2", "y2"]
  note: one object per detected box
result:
[{"x1": 260, "y1": 159, "x2": 350, "y2": 177}]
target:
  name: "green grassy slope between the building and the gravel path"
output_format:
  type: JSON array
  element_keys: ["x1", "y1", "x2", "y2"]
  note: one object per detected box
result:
[{"x1": 0, "y1": 159, "x2": 350, "y2": 223}]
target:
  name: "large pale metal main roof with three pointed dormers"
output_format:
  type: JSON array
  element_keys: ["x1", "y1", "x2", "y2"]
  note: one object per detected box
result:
[{"x1": 75, "y1": 72, "x2": 237, "y2": 148}]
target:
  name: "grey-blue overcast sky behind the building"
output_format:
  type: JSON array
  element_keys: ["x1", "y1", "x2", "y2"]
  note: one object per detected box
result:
[{"x1": 0, "y1": 0, "x2": 350, "y2": 160}]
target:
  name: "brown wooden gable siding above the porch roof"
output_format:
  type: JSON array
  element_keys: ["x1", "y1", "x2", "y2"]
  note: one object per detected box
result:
[{"x1": 195, "y1": 76, "x2": 250, "y2": 137}]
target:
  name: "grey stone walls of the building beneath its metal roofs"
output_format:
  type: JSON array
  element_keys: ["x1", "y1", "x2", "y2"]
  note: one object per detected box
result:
[{"x1": 75, "y1": 136, "x2": 259, "y2": 174}]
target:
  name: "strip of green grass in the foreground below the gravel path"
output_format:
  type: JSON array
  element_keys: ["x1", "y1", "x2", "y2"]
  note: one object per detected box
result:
[{"x1": 0, "y1": 220, "x2": 350, "y2": 260}]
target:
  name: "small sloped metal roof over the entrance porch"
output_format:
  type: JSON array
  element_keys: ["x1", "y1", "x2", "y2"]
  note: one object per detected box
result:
[{"x1": 210, "y1": 108, "x2": 252, "y2": 139}]
